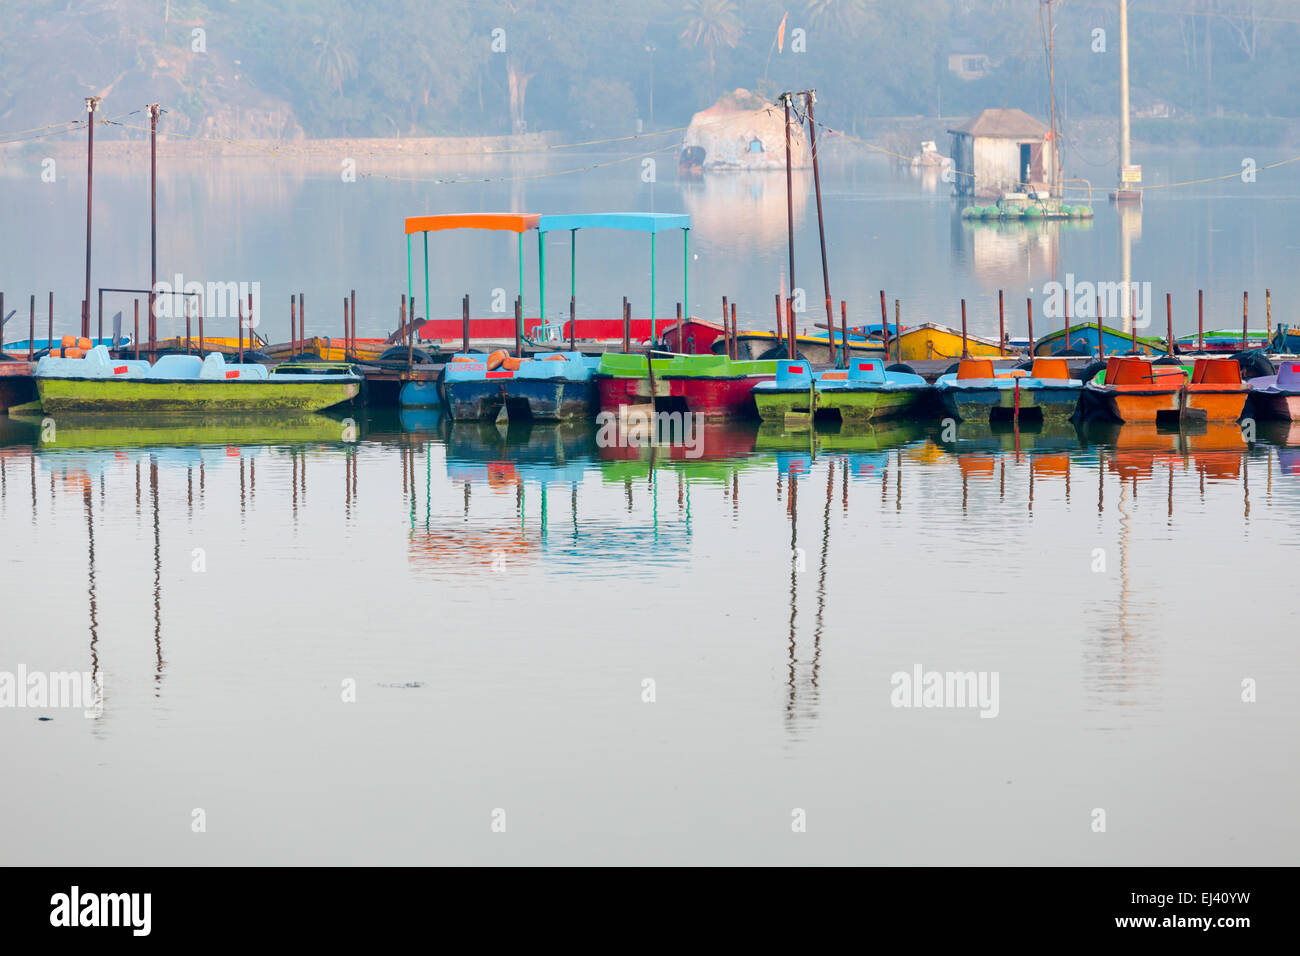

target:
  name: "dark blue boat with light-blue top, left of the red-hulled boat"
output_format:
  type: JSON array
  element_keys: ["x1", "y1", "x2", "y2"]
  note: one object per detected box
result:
[{"x1": 442, "y1": 350, "x2": 599, "y2": 421}]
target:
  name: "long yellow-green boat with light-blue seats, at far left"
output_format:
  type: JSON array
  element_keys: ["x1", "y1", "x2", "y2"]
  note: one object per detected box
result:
[{"x1": 35, "y1": 345, "x2": 361, "y2": 412}]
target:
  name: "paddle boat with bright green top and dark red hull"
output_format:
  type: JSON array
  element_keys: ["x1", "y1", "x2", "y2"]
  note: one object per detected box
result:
[{"x1": 595, "y1": 352, "x2": 777, "y2": 419}]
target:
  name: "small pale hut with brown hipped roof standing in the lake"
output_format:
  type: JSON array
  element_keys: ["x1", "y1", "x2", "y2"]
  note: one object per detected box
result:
[{"x1": 948, "y1": 109, "x2": 1061, "y2": 198}]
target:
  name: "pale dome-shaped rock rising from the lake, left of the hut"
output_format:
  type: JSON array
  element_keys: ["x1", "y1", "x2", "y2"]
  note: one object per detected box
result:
[{"x1": 680, "y1": 90, "x2": 813, "y2": 169}]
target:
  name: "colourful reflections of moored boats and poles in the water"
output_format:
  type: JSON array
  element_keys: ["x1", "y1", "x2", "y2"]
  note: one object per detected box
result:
[{"x1": 0, "y1": 412, "x2": 1300, "y2": 740}]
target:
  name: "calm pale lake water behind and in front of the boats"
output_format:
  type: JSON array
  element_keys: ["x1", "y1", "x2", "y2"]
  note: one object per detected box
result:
[{"x1": 0, "y1": 143, "x2": 1300, "y2": 864}]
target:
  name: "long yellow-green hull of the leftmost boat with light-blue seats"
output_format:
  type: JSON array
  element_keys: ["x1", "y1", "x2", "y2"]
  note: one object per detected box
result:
[{"x1": 36, "y1": 376, "x2": 361, "y2": 412}]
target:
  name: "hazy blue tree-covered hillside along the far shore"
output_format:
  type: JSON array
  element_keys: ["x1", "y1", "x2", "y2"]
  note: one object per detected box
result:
[{"x1": 0, "y1": 0, "x2": 1300, "y2": 138}]
